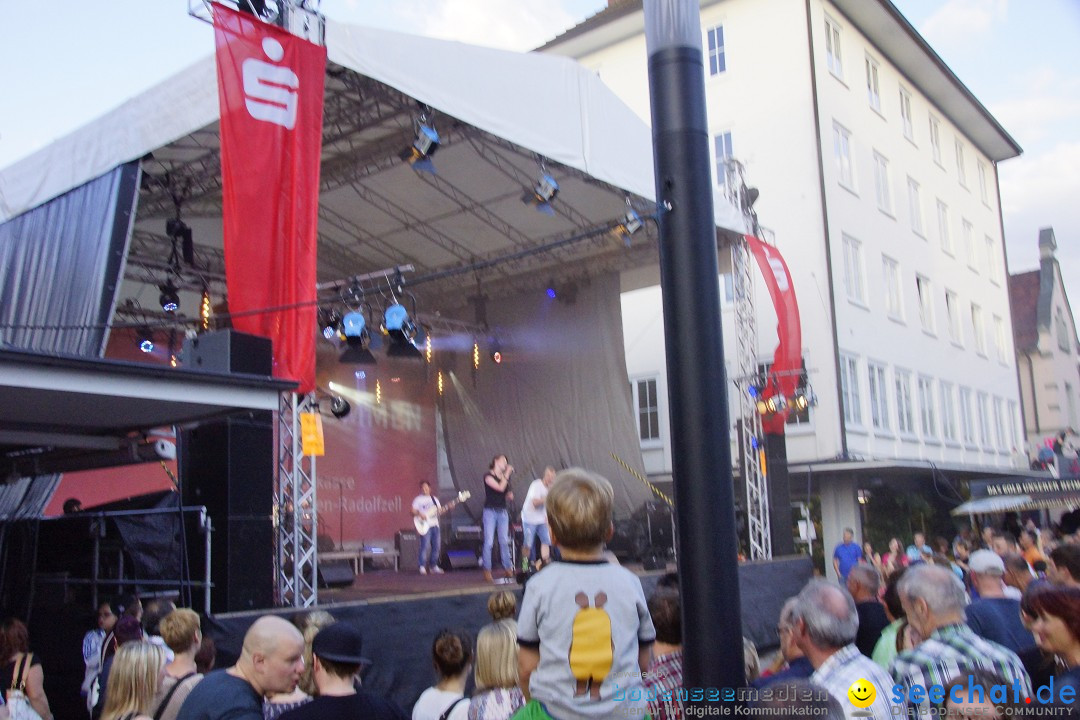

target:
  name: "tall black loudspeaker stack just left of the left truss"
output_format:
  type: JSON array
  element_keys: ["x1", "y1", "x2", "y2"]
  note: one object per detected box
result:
[{"x1": 179, "y1": 411, "x2": 274, "y2": 612}]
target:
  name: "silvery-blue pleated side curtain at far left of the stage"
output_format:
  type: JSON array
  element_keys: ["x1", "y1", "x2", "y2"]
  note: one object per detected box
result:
[{"x1": 0, "y1": 162, "x2": 139, "y2": 517}]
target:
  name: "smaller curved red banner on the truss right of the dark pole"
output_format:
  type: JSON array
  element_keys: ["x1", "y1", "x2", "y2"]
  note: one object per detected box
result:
[{"x1": 744, "y1": 235, "x2": 802, "y2": 435}]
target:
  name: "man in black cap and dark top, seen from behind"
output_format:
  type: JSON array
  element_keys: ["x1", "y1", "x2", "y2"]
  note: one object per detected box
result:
[{"x1": 281, "y1": 621, "x2": 408, "y2": 720}]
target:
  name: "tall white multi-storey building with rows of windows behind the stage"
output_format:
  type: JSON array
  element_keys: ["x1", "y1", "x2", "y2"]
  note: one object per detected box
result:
[{"x1": 541, "y1": 0, "x2": 1027, "y2": 565}]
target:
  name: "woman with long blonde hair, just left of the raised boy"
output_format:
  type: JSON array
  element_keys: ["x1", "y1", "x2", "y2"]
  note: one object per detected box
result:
[{"x1": 469, "y1": 620, "x2": 525, "y2": 720}]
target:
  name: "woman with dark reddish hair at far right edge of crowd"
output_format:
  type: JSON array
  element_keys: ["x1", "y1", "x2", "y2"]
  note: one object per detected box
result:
[{"x1": 1025, "y1": 585, "x2": 1080, "y2": 714}]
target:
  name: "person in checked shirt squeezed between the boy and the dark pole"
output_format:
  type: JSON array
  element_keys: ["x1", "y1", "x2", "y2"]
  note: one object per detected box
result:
[{"x1": 645, "y1": 572, "x2": 686, "y2": 720}]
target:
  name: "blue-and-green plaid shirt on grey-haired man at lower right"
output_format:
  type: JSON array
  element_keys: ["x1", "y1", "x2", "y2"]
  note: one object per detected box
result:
[{"x1": 889, "y1": 623, "x2": 1031, "y2": 717}]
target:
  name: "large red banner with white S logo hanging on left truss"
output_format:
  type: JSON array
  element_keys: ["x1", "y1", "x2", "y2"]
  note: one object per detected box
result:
[{"x1": 214, "y1": 3, "x2": 326, "y2": 393}]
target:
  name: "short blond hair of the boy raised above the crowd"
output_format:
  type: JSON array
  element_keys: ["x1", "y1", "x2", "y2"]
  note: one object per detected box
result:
[{"x1": 546, "y1": 467, "x2": 615, "y2": 549}]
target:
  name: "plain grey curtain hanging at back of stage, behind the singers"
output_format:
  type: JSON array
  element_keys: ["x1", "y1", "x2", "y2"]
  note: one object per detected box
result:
[{"x1": 442, "y1": 275, "x2": 651, "y2": 518}]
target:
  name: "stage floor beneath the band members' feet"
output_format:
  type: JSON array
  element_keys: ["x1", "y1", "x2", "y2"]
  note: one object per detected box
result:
[{"x1": 319, "y1": 562, "x2": 656, "y2": 606}]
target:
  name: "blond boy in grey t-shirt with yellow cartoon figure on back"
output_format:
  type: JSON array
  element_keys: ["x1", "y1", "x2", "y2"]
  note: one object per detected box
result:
[{"x1": 517, "y1": 467, "x2": 656, "y2": 720}]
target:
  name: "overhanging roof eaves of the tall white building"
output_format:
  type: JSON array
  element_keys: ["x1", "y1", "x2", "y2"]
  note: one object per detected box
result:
[{"x1": 537, "y1": 0, "x2": 1023, "y2": 162}]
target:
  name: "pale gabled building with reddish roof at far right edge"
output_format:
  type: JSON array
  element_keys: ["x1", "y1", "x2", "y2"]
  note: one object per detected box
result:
[{"x1": 1009, "y1": 228, "x2": 1080, "y2": 459}]
